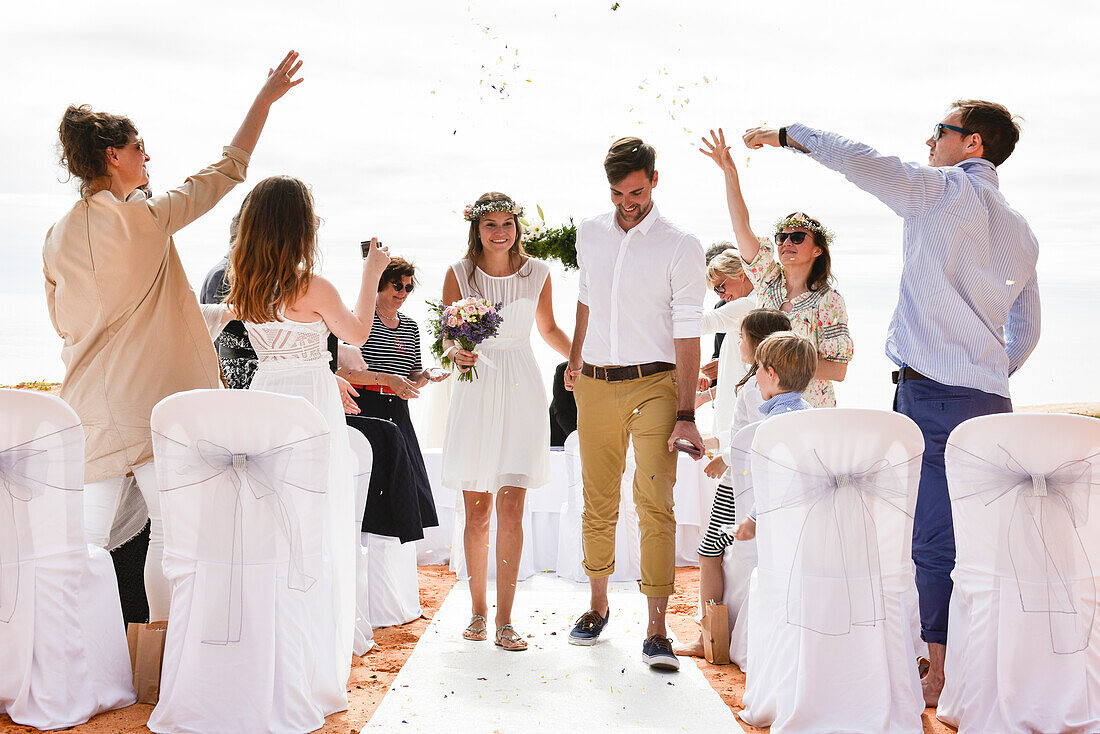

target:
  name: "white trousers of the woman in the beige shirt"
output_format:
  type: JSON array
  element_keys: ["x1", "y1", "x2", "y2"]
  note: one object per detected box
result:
[{"x1": 84, "y1": 461, "x2": 172, "y2": 622}]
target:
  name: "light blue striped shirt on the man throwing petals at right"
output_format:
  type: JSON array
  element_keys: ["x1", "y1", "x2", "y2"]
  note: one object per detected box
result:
[{"x1": 787, "y1": 124, "x2": 1040, "y2": 397}]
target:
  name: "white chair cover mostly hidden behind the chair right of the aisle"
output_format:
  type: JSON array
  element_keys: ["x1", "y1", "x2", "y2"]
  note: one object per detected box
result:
[{"x1": 722, "y1": 421, "x2": 760, "y2": 672}]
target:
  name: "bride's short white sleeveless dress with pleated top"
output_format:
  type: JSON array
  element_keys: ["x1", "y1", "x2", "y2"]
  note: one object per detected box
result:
[{"x1": 442, "y1": 258, "x2": 550, "y2": 493}]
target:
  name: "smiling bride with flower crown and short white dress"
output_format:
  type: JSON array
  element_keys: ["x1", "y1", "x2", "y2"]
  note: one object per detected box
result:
[{"x1": 442, "y1": 191, "x2": 570, "y2": 650}]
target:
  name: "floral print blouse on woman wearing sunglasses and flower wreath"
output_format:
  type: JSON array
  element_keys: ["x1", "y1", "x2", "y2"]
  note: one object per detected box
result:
[{"x1": 745, "y1": 237, "x2": 854, "y2": 408}]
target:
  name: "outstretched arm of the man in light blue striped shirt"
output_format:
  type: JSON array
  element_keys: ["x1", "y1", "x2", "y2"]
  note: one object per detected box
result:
[{"x1": 744, "y1": 124, "x2": 947, "y2": 218}]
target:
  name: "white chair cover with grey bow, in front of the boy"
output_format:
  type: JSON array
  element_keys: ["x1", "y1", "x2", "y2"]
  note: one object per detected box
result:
[{"x1": 741, "y1": 408, "x2": 924, "y2": 734}]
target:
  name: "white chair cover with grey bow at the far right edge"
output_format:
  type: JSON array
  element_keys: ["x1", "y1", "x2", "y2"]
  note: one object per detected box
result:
[{"x1": 937, "y1": 414, "x2": 1100, "y2": 733}]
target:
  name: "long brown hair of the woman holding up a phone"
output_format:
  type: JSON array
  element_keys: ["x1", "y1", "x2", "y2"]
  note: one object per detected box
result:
[{"x1": 227, "y1": 176, "x2": 317, "y2": 324}]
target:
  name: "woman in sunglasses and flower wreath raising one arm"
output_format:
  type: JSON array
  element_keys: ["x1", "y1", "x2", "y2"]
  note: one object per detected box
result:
[{"x1": 699, "y1": 128, "x2": 853, "y2": 408}]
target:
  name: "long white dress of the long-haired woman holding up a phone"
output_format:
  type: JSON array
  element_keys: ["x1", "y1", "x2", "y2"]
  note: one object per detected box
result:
[{"x1": 244, "y1": 318, "x2": 359, "y2": 715}]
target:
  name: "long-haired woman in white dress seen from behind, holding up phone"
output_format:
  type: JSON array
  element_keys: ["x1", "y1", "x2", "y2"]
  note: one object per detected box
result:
[{"x1": 204, "y1": 176, "x2": 389, "y2": 715}]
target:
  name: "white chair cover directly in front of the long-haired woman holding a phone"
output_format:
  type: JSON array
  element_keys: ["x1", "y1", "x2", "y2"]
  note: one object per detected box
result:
[{"x1": 149, "y1": 390, "x2": 338, "y2": 733}]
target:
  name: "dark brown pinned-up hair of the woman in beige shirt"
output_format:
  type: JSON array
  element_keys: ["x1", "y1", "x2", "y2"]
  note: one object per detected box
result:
[{"x1": 57, "y1": 105, "x2": 138, "y2": 199}]
